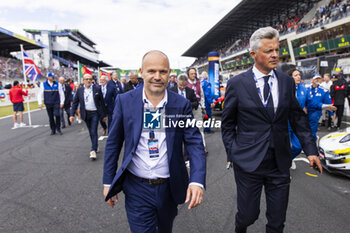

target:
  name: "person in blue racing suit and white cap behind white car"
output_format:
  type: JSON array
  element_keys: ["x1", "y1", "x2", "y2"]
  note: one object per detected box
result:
[{"x1": 306, "y1": 75, "x2": 337, "y2": 140}]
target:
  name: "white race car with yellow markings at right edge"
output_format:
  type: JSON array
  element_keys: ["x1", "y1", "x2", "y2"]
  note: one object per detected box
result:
[{"x1": 319, "y1": 127, "x2": 350, "y2": 177}]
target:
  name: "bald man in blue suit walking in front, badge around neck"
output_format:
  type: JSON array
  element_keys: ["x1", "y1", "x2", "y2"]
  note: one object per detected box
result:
[{"x1": 103, "y1": 50, "x2": 206, "y2": 233}]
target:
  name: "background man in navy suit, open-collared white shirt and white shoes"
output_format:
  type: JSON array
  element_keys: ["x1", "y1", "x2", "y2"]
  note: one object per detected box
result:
[{"x1": 69, "y1": 74, "x2": 107, "y2": 160}]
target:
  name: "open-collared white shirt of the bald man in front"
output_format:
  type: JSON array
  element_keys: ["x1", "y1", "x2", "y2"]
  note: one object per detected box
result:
[{"x1": 128, "y1": 90, "x2": 170, "y2": 179}]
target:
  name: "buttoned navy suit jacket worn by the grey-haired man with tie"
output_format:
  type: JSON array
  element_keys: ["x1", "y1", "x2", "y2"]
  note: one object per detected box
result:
[{"x1": 221, "y1": 69, "x2": 318, "y2": 173}]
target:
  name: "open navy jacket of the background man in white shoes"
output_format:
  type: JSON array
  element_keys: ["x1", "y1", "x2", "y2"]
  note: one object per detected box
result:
[{"x1": 70, "y1": 85, "x2": 106, "y2": 121}]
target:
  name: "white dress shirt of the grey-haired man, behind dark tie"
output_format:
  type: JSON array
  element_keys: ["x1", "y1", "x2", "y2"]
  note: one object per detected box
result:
[{"x1": 253, "y1": 65, "x2": 279, "y2": 112}]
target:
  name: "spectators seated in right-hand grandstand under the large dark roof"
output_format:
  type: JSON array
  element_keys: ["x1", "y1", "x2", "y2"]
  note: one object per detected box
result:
[{"x1": 191, "y1": 0, "x2": 350, "y2": 66}]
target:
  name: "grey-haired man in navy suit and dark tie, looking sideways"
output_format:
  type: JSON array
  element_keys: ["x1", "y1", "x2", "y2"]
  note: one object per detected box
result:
[{"x1": 222, "y1": 27, "x2": 322, "y2": 233}]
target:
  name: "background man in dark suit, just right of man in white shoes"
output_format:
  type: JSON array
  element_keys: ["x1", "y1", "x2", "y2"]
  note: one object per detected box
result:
[{"x1": 100, "y1": 75, "x2": 117, "y2": 135}]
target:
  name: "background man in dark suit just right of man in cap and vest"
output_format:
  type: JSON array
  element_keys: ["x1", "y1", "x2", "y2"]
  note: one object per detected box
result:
[{"x1": 58, "y1": 77, "x2": 73, "y2": 128}]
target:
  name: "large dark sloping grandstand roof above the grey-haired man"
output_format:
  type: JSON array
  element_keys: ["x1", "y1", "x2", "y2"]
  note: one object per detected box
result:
[{"x1": 182, "y1": 0, "x2": 318, "y2": 57}]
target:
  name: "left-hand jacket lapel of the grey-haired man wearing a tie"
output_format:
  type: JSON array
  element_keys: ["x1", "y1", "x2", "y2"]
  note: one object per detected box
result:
[{"x1": 243, "y1": 68, "x2": 270, "y2": 119}]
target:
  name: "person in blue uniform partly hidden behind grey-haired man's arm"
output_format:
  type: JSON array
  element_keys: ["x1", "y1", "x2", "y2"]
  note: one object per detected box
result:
[{"x1": 287, "y1": 69, "x2": 307, "y2": 169}]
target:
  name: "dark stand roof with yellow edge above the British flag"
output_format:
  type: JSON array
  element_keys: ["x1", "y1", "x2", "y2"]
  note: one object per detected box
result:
[{"x1": 0, "y1": 27, "x2": 46, "y2": 53}]
